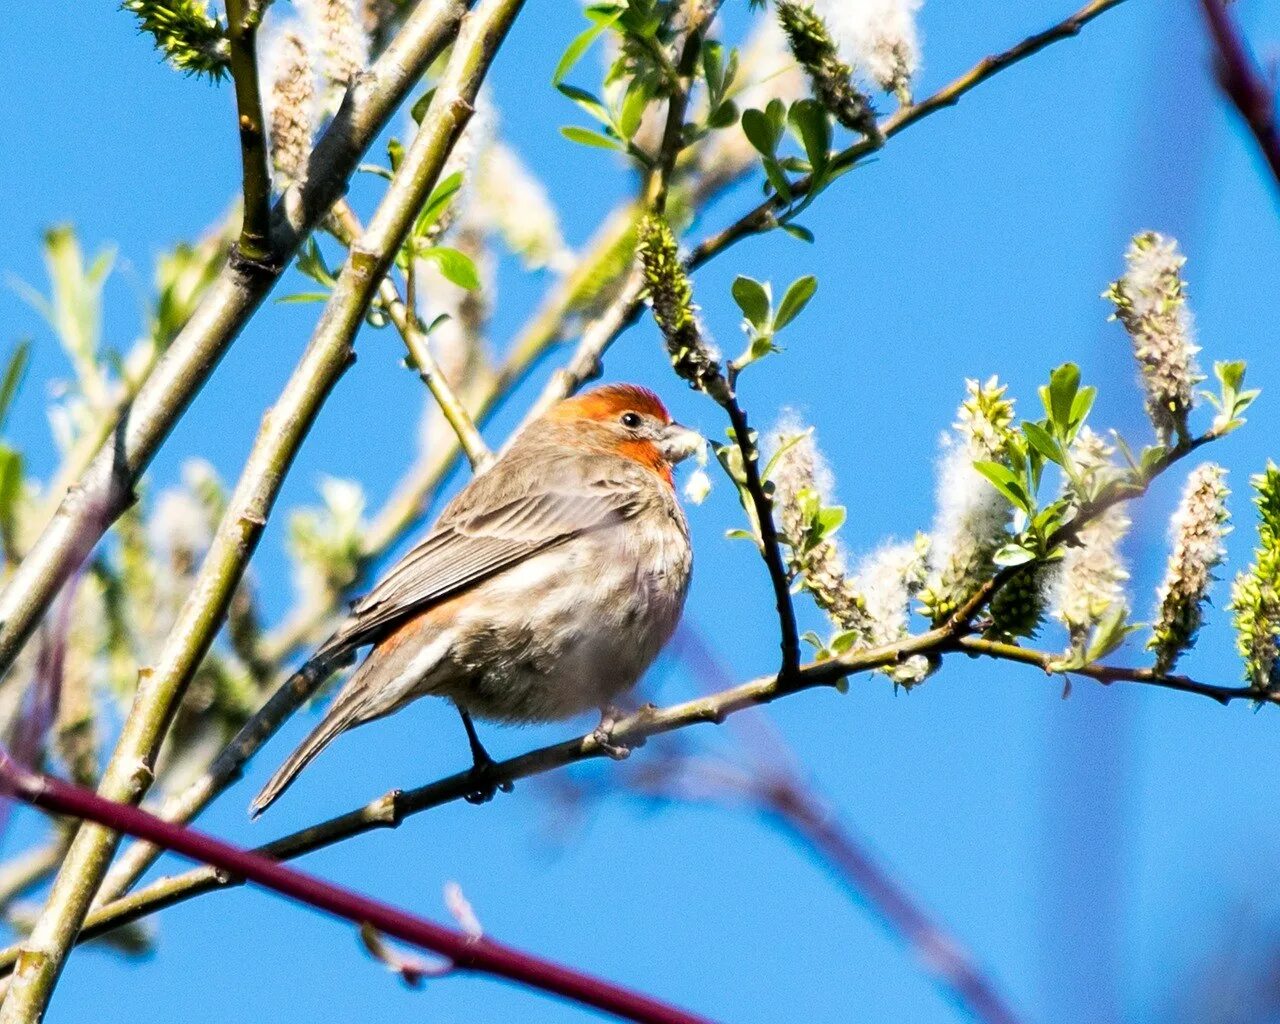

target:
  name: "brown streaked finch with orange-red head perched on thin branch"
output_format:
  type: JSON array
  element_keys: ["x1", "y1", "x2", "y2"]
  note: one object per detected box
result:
[{"x1": 251, "y1": 384, "x2": 703, "y2": 817}]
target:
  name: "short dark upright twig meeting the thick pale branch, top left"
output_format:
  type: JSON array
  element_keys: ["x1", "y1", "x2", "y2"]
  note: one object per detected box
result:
[{"x1": 227, "y1": 0, "x2": 275, "y2": 265}]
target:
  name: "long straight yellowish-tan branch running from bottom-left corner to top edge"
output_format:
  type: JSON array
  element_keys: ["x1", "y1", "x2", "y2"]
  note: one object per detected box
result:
[{"x1": 0, "y1": 0, "x2": 524, "y2": 1024}]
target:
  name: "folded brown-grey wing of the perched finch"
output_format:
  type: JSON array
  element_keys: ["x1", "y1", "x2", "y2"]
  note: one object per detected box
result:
[{"x1": 325, "y1": 466, "x2": 644, "y2": 649}]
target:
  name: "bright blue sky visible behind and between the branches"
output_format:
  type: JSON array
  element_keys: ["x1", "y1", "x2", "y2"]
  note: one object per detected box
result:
[{"x1": 0, "y1": 0, "x2": 1280, "y2": 1024}]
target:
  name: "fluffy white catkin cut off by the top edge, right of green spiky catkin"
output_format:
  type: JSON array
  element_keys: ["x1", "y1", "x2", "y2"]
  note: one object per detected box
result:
[{"x1": 813, "y1": 0, "x2": 923, "y2": 97}]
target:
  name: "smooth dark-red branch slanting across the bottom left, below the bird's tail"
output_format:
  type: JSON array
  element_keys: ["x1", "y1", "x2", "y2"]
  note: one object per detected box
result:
[{"x1": 0, "y1": 751, "x2": 710, "y2": 1024}]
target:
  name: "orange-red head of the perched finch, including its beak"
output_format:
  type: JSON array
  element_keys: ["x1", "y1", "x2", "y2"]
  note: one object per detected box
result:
[{"x1": 547, "y1": 384, "x2": 703, "y2": 484}]
